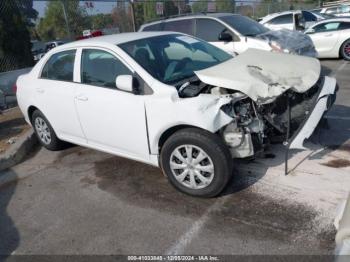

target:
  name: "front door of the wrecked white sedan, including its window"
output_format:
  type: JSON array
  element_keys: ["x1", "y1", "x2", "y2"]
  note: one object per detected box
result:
[{"x1": 75, "y1": 49, "x2": 149, "y2": 160}]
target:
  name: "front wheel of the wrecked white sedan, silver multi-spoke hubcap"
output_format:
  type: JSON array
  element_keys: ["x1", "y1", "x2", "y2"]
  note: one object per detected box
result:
[{"x1": 160, "y1": 128, "x2": 232, "y2": 197}]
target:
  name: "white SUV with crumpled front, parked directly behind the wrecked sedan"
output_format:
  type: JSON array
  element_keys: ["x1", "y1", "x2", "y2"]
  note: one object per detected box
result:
[{"x1": 139, "y1": 13, "x2": 317, "y2": 57}]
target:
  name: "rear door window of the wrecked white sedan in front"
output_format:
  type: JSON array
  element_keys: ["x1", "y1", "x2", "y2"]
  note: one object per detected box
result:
[{"x1": 41, "y1": 50, "x2": 76, "y2": 82}]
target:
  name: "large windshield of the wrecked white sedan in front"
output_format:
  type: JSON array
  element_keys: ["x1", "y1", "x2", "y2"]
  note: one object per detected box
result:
[{"x1": 119, "y1": 34, "x2": 232, "y2": 84}]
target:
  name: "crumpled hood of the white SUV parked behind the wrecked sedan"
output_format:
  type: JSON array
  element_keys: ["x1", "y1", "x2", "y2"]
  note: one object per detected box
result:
[{"x1": 256, "y1": 29, "x2": 317, "y2": 57}]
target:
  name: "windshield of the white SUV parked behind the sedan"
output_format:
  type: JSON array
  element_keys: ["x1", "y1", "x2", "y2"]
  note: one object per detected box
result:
[{"x1": 220, "y1": 15, "x2": 270, "y2": 36}]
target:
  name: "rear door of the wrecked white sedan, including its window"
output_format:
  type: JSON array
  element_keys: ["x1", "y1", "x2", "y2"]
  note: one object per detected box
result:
[{"x1": 35, "y1": 49, "x2": 86, "y2": 144}]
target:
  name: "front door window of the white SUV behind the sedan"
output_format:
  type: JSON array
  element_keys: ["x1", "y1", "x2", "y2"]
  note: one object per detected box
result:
[{"x1": 196, "y1": 18, "x2": 226, "y2": 42}]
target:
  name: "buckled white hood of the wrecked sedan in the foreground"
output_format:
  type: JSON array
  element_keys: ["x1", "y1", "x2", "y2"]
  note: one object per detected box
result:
[{"x1": 195, "y1": 49, "x2": 321, "y2": 104}]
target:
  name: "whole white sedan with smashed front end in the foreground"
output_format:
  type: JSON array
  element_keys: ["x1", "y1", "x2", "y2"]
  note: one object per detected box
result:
[{"x1": 17, "y1": 32, "x2": 336, "y2": 197}]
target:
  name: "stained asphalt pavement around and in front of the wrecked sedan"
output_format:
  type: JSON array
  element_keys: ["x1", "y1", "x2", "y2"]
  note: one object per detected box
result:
[{"x1": 0, "y1": 60, "x2": 350, "y2": 254}]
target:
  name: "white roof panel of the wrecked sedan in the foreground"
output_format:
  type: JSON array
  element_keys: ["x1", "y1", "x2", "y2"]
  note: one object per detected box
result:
[{"x1": 49, "y1": 32, "x2": 175, "y2": 50}]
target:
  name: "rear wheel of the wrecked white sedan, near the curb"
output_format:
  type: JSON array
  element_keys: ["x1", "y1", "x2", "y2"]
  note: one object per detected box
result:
[{"x1": 32, "y1": 110, "x2": 67, "y2": 151}]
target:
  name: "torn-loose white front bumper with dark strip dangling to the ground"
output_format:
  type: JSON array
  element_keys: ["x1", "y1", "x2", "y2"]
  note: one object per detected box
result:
[{"x1": 285, "y1": 77, "x2": 337, "y2": 174}]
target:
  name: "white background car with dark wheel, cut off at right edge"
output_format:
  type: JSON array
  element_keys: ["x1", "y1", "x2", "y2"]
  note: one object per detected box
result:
[{"x1": 305, "y1": 18, "x2": 350, "y2": 60}]
